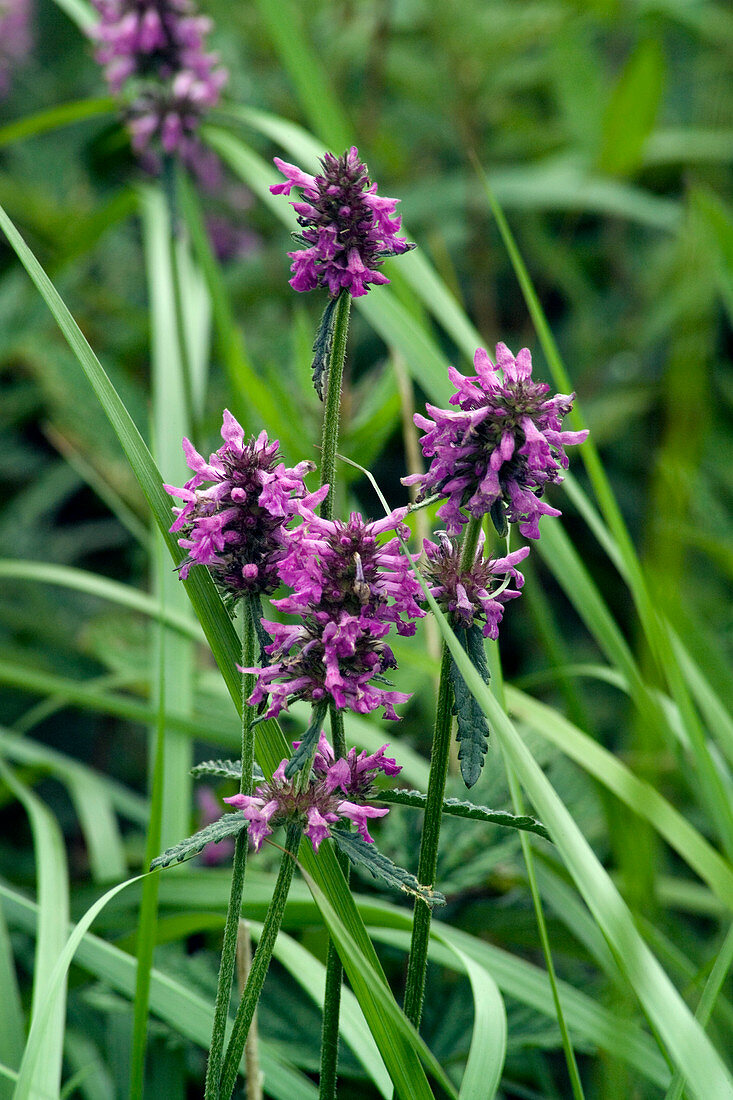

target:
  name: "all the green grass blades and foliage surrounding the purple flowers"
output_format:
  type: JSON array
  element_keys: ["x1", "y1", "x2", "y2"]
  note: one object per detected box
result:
[{"x1": 0, "y1": 0, "x2": 733, "y2": 1100}]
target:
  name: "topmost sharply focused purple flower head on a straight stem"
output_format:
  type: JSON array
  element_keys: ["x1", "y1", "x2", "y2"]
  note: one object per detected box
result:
[{"x1": 270, "y1": 145, "x2": 414, "y2": 298}]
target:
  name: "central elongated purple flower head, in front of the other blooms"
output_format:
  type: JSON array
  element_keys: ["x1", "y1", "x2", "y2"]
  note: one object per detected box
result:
[{"x1": 244, "y1": 506, "x2": 425, "y2": 718}]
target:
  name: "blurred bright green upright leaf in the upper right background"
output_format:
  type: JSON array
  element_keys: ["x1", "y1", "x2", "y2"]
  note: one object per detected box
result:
[{"x1": 598, "y1": 39, "x2": 665, "y2": 175}]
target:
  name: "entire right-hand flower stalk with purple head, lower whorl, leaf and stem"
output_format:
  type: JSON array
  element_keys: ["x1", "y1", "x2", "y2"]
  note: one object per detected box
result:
[{"x1": 403, "y1": 343, "x2": 588, "y2": 1027}]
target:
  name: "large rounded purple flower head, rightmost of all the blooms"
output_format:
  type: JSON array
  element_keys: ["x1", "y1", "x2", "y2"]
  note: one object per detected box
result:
[{"x1": 403, "y1": 343, "x2": 588, "y2": 539}]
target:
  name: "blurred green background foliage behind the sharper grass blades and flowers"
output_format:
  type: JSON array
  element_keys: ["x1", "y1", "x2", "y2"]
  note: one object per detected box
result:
[{"x1": 0, "y1": 0, "x2": 733, "y2": 1100}]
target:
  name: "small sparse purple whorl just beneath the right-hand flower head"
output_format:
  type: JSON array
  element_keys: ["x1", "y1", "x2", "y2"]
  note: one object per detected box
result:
[{"x1": 423, "y1": 531, "x2": 529, "y2": 638}]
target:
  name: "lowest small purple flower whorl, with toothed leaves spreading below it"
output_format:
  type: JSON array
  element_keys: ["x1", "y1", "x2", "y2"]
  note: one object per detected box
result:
[{"x1": 225, "y1": 733, "x2": 402, "y2": 851}]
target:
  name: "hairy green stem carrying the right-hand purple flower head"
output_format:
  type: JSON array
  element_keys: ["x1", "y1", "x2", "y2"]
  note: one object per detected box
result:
[{"x1": 404, "y1": 518, "x2": 481, "y2": 1027}]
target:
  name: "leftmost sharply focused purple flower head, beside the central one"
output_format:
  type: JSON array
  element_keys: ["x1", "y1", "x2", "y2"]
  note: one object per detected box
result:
[{"x1": 164, "y1": 409, "x2": 314, "y2": 596}]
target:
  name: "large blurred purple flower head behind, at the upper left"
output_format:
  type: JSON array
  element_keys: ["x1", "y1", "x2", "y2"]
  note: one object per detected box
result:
[{"x1": 90, "y1": 0, "x2": 227, "y2": 183}]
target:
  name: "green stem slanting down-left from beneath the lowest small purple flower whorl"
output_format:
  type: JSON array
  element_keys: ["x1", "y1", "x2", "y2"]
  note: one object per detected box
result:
[{"x1": 219, "y1": 825, "x2": 302, "y2": 1100}]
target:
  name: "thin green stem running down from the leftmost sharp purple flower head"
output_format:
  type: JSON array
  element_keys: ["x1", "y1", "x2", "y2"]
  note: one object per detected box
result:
[{"x1": 204, "y1": 601, "x2": 256, "y2": 1100}]
